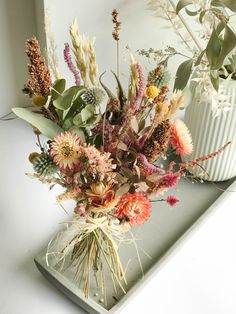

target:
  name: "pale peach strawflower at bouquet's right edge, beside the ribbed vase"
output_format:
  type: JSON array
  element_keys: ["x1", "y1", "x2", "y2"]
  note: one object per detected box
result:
[{"x1": 170, "y1": 119, "x2": 193, "y2": 156}]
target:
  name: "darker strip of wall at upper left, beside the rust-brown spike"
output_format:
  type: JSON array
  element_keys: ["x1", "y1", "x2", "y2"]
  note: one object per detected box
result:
[{"x1": 0, "y1": 0, "x2": 36, "y2": 115}]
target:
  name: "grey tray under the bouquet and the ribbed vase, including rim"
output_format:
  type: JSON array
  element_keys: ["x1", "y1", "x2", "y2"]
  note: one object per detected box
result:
[{"x1": 35, "y1": 179, "x2": 236, "y2": 314}]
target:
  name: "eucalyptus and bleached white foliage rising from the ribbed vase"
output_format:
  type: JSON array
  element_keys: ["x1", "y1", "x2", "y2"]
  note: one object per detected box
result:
[{"x1": 149, "y1": 0, "x2": 236, "y2": 90}]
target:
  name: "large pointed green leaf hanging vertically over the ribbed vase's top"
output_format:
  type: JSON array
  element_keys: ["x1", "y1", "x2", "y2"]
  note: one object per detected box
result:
[{"x1": 206, "y1": 29, "x2": 222, "y2": 69}]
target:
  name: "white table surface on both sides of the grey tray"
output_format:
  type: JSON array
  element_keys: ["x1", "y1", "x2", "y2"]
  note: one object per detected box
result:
[{"x1": 0, "y1": 120, "x2": 236, "y2": 314}]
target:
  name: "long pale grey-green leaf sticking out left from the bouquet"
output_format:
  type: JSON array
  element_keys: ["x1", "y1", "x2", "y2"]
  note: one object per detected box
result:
[{"x1": 12, "y1": 108, "x2": 63, "y2": 138}]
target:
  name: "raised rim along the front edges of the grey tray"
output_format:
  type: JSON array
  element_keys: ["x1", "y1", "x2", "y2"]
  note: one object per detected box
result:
[{"x1": 34, "y1": 178, "x2": 236, "y2": 314}]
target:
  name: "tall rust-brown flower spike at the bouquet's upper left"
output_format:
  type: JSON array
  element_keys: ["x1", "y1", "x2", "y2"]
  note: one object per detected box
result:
[{"x1": 23, "y1": 37, "x2": 52, "y2": 97}]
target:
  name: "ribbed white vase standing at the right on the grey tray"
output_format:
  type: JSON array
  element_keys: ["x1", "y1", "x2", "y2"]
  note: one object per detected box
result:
[{"x1": 184, "y1": 80, "x2": 236, "y2": 181}]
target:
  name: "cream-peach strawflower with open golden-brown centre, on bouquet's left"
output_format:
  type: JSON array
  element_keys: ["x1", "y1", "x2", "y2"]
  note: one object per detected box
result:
[{"x1": 50, "y1": 132, "x2": 80, "y2": 169}]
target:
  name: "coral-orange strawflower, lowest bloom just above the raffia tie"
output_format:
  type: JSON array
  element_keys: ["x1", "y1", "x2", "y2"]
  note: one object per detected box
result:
[{"x1": 114, "y1": 192, "x2": 151, "y2": 225}]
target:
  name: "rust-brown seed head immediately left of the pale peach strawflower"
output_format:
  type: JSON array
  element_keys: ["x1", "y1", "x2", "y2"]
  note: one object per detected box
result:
[{"x1": 142, "y1": 120, "x2": 170, "y2": 163}]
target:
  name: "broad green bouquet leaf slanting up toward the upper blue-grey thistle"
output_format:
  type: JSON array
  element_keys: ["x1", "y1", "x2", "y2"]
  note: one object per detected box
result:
[{"x1": 53, "y1": 86, "x2": 84, "y2": 110}]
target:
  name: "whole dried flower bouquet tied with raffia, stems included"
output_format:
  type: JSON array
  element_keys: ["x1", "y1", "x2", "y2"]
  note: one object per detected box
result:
[{"x1": 10, "y1": 11, "x2": 228, "y2": 302}]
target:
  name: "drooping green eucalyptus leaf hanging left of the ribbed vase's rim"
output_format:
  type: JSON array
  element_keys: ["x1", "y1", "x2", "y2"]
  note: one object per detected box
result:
[{"x1": 174, "y1": 59, "x2": 193, "y2": 90}]
